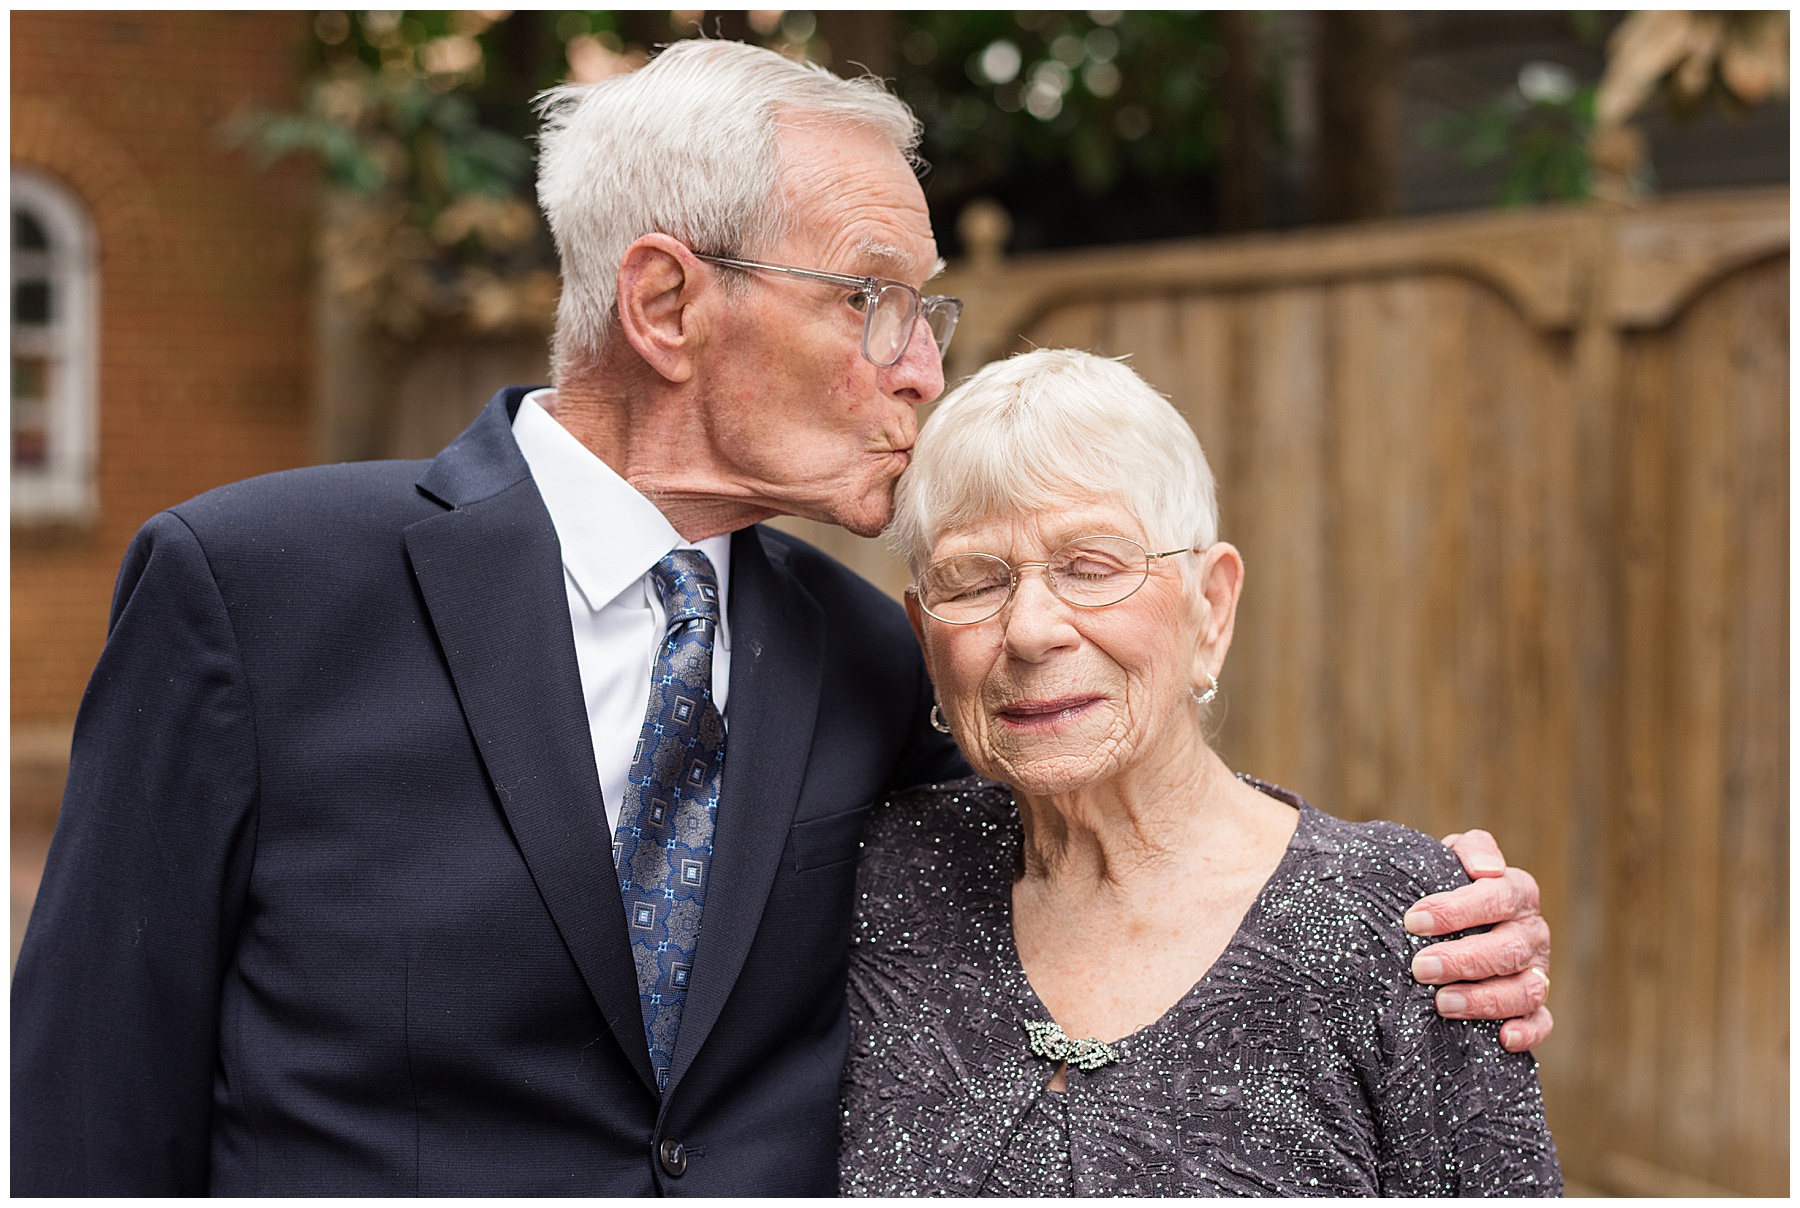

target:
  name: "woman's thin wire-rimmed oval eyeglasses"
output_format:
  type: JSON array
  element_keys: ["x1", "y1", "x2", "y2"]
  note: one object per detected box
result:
[{"x1": 907, "y1": 536, "x2": 1195, "y2": 625}]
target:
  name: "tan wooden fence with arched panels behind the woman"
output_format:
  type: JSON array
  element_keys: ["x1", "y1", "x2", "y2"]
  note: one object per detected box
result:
[{"x1": 790, "y1": 189, "x2": 1787, "y2": 1195}]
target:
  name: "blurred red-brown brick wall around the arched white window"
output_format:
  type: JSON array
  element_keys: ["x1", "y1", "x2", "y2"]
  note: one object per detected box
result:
[{"x1": 11, "y1": 11, "x2": 311, "y2": 832}]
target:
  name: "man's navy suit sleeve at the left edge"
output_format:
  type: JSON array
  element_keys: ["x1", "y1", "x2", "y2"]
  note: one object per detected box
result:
[{"x1": 13, "y1": 513, "x2": 257, "y2": 1195}]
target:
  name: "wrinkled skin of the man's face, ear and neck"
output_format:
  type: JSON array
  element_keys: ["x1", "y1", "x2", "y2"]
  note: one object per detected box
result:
[{"x1": 553, "y1": 126, "x2": 943, "y2": 540}]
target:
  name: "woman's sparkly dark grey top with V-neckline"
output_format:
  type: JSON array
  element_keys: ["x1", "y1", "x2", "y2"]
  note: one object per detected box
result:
[{"x1": 841, "y1": 778, "x2": 1562, "y2": 1195}]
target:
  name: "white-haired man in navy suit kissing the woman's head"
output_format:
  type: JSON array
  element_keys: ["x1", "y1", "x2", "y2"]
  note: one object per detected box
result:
[{"x1": 13, "y1": 41, "x2": 1548, "y2": 1195}]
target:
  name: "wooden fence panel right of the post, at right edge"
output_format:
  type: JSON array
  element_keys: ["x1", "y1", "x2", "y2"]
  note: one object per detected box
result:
[{"x1": 1609, "y1": 259, "x2": 1787, "y2": 1194}]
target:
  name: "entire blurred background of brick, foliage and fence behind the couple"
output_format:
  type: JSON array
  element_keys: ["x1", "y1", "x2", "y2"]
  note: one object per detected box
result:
[{"x1": 11, "y1": 11, "x2": 1789, "y2": 1195}]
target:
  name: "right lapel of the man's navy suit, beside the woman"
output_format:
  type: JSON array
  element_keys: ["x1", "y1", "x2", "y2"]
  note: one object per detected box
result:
[{"x1": 666, "y1": 527, "x2": 824, "y2": 1089}]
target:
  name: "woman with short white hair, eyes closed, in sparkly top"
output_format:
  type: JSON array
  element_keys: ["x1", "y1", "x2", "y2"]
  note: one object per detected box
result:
[{"x1": 842, "y1": 351, "x2": 1561, "y2": 1195}]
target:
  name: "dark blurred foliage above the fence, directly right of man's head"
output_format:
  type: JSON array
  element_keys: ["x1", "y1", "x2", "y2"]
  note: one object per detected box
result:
[{"x1": 895, "y1": 11, "x2": 1296, "y2": 254}]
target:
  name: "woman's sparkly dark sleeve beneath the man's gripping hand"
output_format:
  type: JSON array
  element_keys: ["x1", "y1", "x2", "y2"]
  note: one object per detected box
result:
[{"x1": 1375, "y1": 835, "x2": 1562, "y2": 1195}]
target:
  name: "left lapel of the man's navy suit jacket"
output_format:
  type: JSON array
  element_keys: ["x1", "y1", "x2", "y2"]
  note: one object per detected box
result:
[{"x1": 405, "y1": 391, "x2": 662, "y2": 1095}]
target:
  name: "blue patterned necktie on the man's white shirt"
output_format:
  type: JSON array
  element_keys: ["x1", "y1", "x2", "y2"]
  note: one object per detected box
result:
[{"x1": 612, "y1": 549, "x2": 725, "y2": 1089}]
